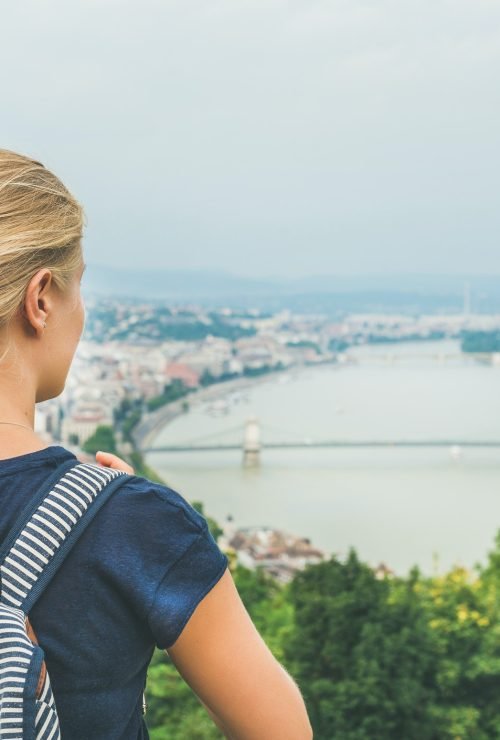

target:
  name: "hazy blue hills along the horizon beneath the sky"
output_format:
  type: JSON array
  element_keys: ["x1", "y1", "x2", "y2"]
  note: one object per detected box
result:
[{"x1": 83, "y1": 263, "x2": 500, "y2": 315}]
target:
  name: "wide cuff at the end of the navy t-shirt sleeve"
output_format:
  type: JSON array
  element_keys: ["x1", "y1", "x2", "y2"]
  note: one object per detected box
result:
[{"x1": 149, "y1": 524, "x2": 228, "y2": 649}]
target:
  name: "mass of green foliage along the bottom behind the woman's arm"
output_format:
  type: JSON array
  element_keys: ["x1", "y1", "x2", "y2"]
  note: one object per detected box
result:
[{"x1": 142, "y1": 528, "x2": 500, "y2": 740}]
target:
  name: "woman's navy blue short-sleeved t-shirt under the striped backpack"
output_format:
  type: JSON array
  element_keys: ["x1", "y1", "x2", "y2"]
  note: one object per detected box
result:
[{"x1": 0, "y1": 445, "x2": 228, "y2": 740}]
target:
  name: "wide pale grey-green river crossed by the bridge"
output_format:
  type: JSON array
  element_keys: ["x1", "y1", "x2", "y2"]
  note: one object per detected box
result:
[{"x1": 147, "y1": 341, "x2": 500, "y2": 575}]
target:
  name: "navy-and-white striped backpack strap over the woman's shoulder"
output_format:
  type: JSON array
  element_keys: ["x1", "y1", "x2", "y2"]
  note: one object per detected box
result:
[{"x1": 0, "y1": 460, "x2": 131, "y2": 614}]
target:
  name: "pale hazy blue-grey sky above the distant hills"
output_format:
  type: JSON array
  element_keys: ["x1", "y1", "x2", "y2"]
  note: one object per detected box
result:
[{"x1": 0, "y1": 0, "x2": 500, "y2": 276}]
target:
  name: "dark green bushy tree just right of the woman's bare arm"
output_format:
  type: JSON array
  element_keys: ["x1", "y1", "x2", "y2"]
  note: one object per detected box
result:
[{"x1": 285, "y1": 549, "x2": 437, "y2": 740}]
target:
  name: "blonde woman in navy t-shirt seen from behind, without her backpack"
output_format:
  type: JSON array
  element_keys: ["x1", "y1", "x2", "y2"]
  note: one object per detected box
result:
[{"x1": 0, "y1": 150, "x2": 312, "y2": 740}]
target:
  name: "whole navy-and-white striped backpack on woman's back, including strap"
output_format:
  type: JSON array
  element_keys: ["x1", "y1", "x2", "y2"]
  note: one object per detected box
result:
[{"x1": 0, "y1": 460, "x2": 131, "y2": 740}]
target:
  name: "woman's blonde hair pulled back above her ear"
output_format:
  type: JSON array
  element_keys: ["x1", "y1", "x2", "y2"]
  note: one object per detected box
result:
[{"x1": 0, "y1": 149, "x2": 84, "y2": 331}]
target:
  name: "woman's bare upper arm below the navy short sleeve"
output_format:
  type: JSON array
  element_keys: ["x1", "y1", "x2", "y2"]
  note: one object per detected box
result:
[{"x1": 167, "y1": 569, "x2": 313, "y2": 740}]
